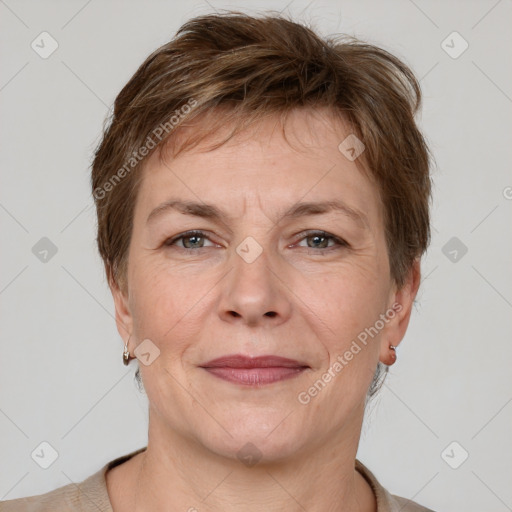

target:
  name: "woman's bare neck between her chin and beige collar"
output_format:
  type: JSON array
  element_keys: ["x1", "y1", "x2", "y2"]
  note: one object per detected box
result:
[{"x1": 108, "y1": 413, "x2": 376, "y2": 512}]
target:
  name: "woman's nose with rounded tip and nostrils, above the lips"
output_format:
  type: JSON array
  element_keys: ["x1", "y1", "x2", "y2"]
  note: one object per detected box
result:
[{"x1": 219, "y1": 245, "x2": 292, "y2": 327}]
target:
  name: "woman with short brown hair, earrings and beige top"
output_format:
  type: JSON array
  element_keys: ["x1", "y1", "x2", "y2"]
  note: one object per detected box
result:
[{"x1": 2, "y1": 12, "x2": 438, "y2": 512}]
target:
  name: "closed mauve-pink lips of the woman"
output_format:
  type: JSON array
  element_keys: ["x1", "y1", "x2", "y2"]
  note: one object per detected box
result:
[{"x1": 200, "y1": 354, "x2": 309, "y2": 386}]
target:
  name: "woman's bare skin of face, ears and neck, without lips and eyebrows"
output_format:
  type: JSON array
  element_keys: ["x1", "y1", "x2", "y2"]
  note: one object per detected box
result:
[{"x1": 107, "y1": 106, "x2": 420, "y2": 512}]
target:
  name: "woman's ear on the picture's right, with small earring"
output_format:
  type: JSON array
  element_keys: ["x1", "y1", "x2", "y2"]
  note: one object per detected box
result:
[{"x1": 379, "y1": 259, "x2": 421, "y2": 365}]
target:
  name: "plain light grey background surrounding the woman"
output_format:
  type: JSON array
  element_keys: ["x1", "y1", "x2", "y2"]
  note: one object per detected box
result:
[{"x1": 0, "y1": 0, "x2": 512, "y2": 512}]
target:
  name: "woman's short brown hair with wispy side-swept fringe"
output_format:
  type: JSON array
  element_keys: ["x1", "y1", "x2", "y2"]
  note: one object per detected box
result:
[{"x1": 92, "y1": 11, "x2": 431, "y2": 394}]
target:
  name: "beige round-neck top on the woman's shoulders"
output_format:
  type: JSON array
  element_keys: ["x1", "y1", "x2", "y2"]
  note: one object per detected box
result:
[{"x1": 0, "y1": 447, "x2": 434, "y2": 512}]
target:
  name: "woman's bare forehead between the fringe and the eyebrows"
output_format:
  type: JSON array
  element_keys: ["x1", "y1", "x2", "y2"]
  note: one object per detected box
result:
[{"x1": 136, "y1": 110, "x2": 381, "y2": 229}]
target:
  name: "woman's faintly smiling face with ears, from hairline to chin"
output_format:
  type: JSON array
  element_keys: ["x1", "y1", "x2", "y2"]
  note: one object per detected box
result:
[{"x1": 113, "y1": 111, "x2": 417, "y2": 460}]
